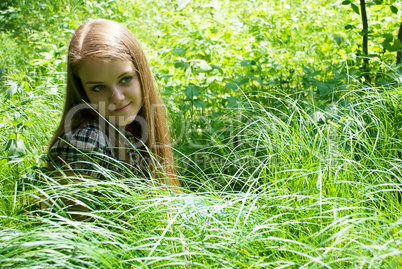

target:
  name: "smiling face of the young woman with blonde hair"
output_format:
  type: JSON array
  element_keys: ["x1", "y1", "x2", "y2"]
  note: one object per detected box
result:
[{"x1": 78, "y1": 59, "x2": 142, "y2": 126}]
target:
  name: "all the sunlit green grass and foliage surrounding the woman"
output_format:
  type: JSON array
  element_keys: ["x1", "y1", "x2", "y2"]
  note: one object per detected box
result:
[{"x1": 0, "y1": 0, "x2": 402, "y2": 268}]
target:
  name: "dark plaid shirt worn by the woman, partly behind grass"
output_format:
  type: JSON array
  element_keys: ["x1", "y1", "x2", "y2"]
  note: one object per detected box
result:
[{"x1": 48, "y1": 122, "x2": 146, "y2": 178}]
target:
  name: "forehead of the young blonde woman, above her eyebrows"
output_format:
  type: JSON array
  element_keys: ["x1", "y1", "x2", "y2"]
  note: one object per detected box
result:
[{"x1": 77, "y1": 59, "x2": 135, "y2": 83}]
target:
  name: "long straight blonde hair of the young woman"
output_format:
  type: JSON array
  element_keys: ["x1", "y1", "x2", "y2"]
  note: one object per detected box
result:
[{"x1": 49, "y1": 19, "x2": 179, "y2": 186}]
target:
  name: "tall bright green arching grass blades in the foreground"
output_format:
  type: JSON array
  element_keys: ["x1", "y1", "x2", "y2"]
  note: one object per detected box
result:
[{"x1": 0, "y1": 84, "x2": 402, "y2": 268}]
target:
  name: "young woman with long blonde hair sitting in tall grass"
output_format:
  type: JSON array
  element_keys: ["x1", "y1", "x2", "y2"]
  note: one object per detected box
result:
[{"x1": 49, "y1": 19, "x2": 179, "y2": 192}]
